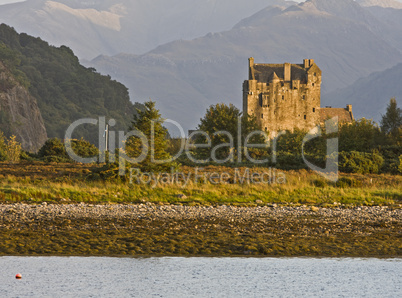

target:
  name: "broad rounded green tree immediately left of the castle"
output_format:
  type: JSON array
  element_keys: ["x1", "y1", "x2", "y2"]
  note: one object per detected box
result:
[{"x1": 194, "y1": 104, "x2": 266, "y2": 162}]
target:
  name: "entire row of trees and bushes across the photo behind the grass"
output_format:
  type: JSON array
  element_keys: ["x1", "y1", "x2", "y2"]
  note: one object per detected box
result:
[{"x1": 0, "y1": 99, "x2": 402, "y2": 179}]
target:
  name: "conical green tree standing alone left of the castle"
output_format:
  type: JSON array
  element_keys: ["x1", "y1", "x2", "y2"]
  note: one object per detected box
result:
[{"x1": 126, "y1": 101, "x2": 177, "y2": 172}]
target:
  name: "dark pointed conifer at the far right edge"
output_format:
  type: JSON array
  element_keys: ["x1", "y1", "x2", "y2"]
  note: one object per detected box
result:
[{"x1": 381, "y1": 97, "x2": 402, "y2": 143}]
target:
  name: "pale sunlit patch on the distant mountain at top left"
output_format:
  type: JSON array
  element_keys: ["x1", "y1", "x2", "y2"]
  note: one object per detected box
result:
[{"x1": 43, "y1": 1, "x2": 125, "y2": 31}]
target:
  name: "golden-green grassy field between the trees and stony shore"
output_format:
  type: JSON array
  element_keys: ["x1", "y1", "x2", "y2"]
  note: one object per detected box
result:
[{"x1": 0, "y1": 163, "x2": 402, "y2": 208}]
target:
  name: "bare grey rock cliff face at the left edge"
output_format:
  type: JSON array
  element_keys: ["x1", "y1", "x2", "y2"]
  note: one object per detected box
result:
[{"x1": 0, "y1": 62, "x2": 47, "y2": 152}]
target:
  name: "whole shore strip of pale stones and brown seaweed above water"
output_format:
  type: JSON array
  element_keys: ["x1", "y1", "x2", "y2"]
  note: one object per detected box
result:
[{"x1": 0, "y1": 203, "x2": 402, "y2": 258}]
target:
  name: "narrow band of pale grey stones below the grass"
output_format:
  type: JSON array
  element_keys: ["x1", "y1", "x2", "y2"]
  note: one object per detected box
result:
[{"x1": 0, "y1": 203, "x2": 402, "y2": 224}]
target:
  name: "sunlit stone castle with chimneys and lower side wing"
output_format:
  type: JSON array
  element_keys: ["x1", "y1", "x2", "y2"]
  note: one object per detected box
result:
[{"x1": 243, "y1": 58, "x2": 353, "y2": 136}]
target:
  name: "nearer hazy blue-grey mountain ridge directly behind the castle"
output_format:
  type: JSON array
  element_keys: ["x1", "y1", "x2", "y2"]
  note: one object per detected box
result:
[{"x1": 89, "y1": 0, "x2": 402, "y2": 128}]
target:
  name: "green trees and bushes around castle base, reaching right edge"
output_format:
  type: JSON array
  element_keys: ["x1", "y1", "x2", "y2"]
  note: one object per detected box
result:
[{"x1": 172, "y1": 98, "x2": 402, "y2": 174}]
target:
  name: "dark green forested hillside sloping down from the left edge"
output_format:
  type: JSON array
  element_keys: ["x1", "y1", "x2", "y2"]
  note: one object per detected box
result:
[{"x1": 0, "y1": 24, "x2": 140, "y2": 143}]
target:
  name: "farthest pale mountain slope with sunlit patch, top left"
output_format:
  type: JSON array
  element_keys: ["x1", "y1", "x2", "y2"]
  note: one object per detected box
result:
[{"x1": 0, "y1": 0, "x2": 295, "y2": 59}]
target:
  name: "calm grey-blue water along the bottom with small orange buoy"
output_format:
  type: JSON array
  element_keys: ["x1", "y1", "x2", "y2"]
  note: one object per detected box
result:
[{"x1": 0, "y1": 257, "x2": 402, "y2": 297}]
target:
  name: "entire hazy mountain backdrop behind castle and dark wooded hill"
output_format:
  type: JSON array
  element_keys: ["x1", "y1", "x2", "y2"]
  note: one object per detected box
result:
[{"x1": 0, "y1": 0, "x2": 402, "y2": 129}]
